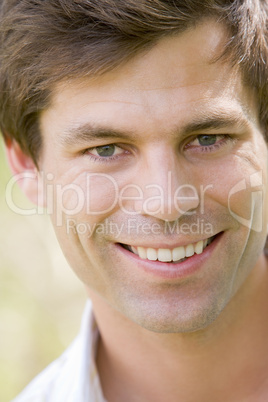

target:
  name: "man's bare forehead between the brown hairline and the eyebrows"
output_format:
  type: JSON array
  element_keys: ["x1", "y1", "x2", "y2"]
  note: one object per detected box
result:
[{"x1": 41, "y1": 20, "x2": 257, "y2": 143}]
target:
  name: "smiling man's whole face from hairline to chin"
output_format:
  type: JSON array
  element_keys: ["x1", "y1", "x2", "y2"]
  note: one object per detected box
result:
[{"x1": 37, "y1": 21, "x2": 267, "y2": 332}]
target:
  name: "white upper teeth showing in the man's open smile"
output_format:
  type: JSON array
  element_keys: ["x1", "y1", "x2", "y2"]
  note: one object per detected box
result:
[{"x1": 119, "y1": 235, "x2": 218, "y2": 264}]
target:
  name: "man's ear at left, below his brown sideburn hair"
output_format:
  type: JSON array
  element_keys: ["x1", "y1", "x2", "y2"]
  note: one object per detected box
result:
[{"x1": 6, "y1": 140, "x2": 45, "y2": 207}]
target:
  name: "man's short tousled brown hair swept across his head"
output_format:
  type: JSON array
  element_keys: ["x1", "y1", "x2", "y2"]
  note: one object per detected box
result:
[{"x1": 0, "y1": 0, "x2": 268, "y2": 164}]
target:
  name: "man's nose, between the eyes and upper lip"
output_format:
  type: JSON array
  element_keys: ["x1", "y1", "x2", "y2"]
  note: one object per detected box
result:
[{"x1": 130, "y1": 149, "x2": 199, "y2": 221}]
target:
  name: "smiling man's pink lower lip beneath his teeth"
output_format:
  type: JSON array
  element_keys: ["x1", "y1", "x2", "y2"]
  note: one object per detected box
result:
[{"x1": 116, "y1": 233, "x2": 223, "y2": 279}]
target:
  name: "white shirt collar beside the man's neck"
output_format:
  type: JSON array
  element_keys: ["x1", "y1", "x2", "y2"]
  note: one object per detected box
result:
[{"x1": 13, "y1": 301, "x2": 105, "y2": 402}]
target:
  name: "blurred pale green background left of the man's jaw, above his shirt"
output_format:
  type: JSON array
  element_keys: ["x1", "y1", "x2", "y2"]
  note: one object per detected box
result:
[{"x1": 0, "y1": 141, "x2": 86, "y2": 402}]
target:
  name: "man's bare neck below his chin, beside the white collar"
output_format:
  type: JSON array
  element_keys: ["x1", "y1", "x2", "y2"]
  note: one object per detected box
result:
[{"x1": 90, "y1": 257, "x2": 268, "y2": 402}]
